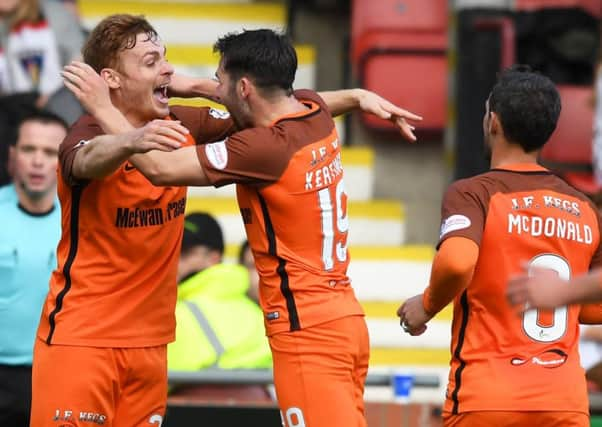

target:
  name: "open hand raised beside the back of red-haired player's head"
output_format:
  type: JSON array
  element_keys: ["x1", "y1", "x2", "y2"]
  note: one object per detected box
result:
[{"x1": 61, "y1": 61, "x2": 113, "y2": 116}]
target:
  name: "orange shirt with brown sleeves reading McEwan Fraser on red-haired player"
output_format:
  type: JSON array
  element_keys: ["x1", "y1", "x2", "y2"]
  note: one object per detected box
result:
[{"x1": 38, "y1": 107, "x2": 233, "y2": 347}]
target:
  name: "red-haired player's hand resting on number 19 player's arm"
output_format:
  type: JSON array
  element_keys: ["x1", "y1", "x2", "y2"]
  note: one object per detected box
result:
[{"x1": 126, "y1": 119, "x2": 188, "y2": 153}]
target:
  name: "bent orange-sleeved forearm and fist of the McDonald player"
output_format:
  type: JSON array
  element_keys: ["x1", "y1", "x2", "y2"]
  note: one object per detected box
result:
[{"x1": 397, "y1": 237, "x2": 479, "y2": 335}]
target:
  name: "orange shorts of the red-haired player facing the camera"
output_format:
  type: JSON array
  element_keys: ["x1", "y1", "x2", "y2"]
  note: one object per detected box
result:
[{"x1": 31, "y1": 339, "x2": 167, "y2": 427}]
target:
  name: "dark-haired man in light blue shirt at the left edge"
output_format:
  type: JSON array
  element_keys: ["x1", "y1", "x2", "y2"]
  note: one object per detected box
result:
[{"x1": 0, "y1": 112, "x2": 67, "y2": 427}]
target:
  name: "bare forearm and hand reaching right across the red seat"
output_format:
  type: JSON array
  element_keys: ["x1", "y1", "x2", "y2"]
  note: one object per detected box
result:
[{"x1": 318, "y1": 89, "x2": 422, "y2": 142}]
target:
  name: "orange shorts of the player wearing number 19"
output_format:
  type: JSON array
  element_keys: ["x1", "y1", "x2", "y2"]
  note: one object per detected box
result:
[{"x1": 269, "y1": 316, "x2": 370, "y2": 427}]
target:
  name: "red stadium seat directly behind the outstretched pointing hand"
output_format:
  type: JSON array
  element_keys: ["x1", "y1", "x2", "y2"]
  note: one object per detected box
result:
[{"x1": 351, "y1": 0, "x2": 448, "y2": 132}]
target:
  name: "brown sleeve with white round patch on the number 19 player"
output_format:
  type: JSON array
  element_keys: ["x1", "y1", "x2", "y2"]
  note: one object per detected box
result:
[{"x1": 197, "y1": 127, "x2": 289, "y2": 187}]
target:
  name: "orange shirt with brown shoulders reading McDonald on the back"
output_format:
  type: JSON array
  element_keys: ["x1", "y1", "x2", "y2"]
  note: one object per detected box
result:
[{"x1": 440, "y1": 165, "x2": 602, "y2": 414}]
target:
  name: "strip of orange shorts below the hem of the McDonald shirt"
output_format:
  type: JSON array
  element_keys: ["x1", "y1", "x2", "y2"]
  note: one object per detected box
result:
[{"x1": 443, "y1": 411, "x2": 590, "y2": 427}]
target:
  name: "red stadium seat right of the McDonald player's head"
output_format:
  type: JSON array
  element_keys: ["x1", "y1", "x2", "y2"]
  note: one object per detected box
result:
[{"x1": 540, "y1": 85, "x2": 600, "y2": 194}]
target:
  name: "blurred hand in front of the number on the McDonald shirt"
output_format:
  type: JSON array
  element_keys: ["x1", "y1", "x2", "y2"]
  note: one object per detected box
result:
[{"x1": 506, "y1": 268, "x2": 569, "y2": 313}]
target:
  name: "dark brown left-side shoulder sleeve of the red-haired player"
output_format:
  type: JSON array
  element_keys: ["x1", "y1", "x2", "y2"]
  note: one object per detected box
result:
[{"x1": 59, "y1": 116, "x2": 104, "y2": 186}]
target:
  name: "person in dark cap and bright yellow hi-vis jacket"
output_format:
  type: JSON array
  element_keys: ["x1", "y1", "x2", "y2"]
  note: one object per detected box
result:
[{"x1": 167, "y1": 213, "x2": 272, "y2": 371}]
